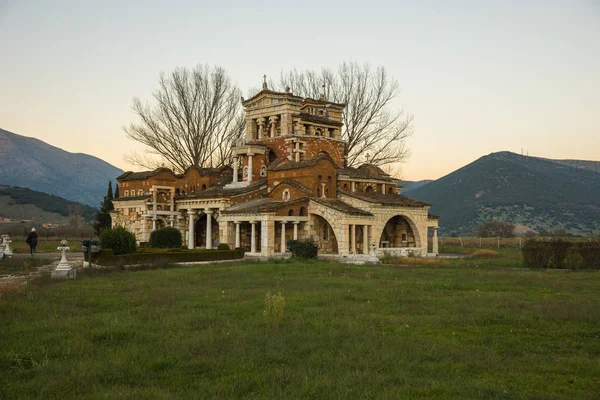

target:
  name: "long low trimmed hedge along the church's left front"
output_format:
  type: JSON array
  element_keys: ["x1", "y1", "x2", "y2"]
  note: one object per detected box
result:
[{"x1": 85, "y1": 249, "x2": 244, "y2": 265}]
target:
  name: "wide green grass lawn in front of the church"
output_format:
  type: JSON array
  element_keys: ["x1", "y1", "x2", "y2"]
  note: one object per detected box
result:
[{"x1": 0, "y1": 259, "x2": 600, "y2": 399}]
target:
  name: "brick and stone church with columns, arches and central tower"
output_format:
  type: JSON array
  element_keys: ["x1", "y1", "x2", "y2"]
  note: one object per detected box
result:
[{"x1": 111, "y1": 85, "x2": 439, "y2": 260}]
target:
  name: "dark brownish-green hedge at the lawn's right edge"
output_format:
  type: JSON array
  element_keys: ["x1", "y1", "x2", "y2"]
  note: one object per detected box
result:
[{"x1": 521, "y1": 239, "x2": 600, "y2": 269}]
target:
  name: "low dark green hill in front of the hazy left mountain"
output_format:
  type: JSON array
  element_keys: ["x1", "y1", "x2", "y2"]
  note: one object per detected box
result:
[{"x1": 0, "y1": 185, "x2": 97, "y2": 223}]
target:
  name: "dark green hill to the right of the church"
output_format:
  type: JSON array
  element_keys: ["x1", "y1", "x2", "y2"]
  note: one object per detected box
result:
[{"x1": 410, "y1": 152, "x2": 600, "y2": 235}]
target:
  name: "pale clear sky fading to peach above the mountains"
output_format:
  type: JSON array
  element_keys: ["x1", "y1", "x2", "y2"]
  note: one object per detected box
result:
[{"x1": 0, "y1": 0, "x2": 600, "y2": 180}]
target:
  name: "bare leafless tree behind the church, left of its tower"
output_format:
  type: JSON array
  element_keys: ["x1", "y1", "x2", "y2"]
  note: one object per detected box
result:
[{"x1": 124, "y1": 65, "x2": 244, "y2": 172}]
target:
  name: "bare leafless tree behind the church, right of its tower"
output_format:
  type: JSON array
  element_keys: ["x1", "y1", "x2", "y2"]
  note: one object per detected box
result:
[{"x1": 279, "y1": 62, "x2": 413, "y2": 166}]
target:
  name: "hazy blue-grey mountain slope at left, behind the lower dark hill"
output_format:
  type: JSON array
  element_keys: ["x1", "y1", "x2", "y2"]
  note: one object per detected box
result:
[{"x1": 0, "y1": 129, "x2": 123, "y2": 207}]
